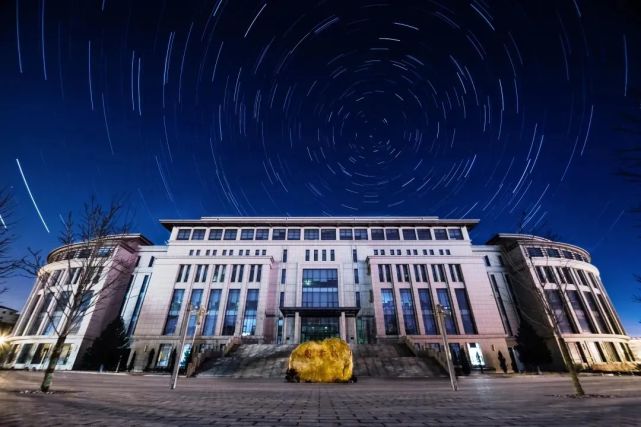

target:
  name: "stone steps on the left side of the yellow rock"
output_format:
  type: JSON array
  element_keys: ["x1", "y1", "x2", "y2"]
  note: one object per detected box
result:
[{"x1": 197, "y1": 344, "x2": 296, "y2": 378}]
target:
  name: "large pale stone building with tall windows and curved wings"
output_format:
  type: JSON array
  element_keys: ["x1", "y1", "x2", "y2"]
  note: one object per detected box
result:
[{"x1": 5, "y1": 217, "x2": 632, "y2": 371}]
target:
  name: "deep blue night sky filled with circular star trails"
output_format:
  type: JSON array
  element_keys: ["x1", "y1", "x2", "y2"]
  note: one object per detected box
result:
[{"x1": 0, "y1": 0, "x2": 641, "y2": 336}]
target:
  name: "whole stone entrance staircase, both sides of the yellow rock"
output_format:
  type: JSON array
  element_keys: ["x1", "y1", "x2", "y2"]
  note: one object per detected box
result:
[{"x1": 197, "y1": 343, "x2": 446, "y2": 378}]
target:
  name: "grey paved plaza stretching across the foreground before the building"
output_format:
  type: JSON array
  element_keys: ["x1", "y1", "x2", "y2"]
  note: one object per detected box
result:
[{"x1": 0, "y1": 371, "x2": 641, "y2": 427}]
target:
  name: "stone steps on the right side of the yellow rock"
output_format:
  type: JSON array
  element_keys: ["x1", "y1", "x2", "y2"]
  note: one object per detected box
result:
[{"x1": 352, "y1": 343, "x2": 446, "y2": 378}]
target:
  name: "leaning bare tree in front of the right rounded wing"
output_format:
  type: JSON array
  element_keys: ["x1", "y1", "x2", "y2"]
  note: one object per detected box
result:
[{"x1": 507, "y1": 249, "x2": 585, "y2": 396}]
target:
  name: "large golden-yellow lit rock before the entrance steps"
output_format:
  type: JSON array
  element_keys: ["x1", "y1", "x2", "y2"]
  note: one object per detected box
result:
[{"x1": 287, "y1": 338, "x2": 353, "y2": 383}]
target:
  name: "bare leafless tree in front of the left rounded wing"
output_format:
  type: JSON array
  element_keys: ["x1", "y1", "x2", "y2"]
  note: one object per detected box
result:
[{"x1": 26, "y1": 197, "x2": 133, "y2": 392}]
